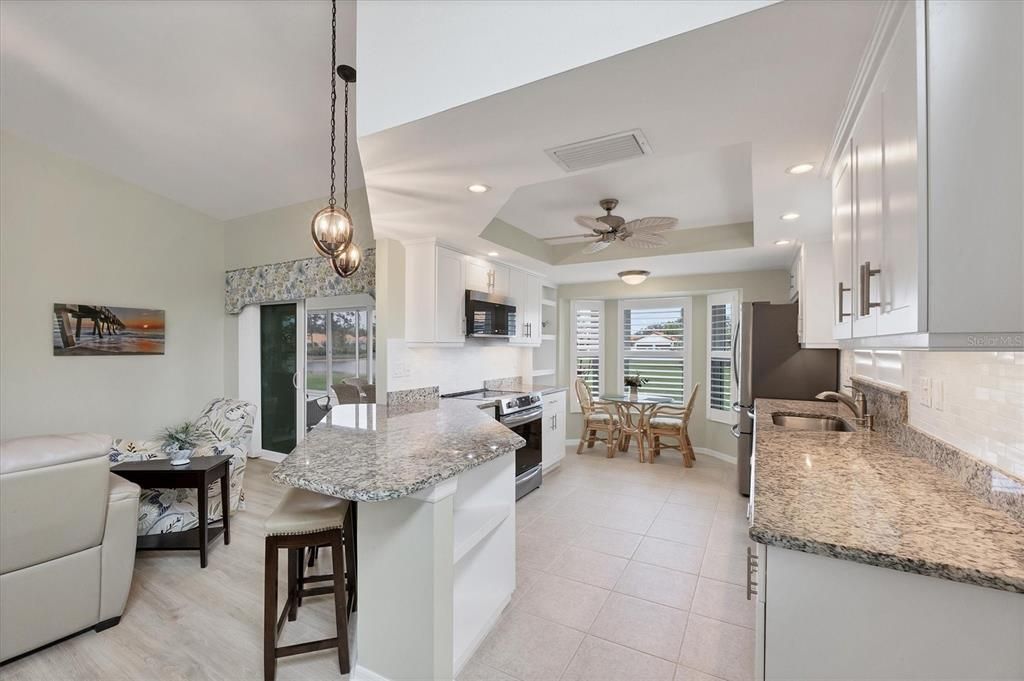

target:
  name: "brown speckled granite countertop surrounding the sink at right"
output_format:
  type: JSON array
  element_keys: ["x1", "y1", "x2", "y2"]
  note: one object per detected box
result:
[{"x1": 750, "y1": 399, "x2": 1024, "y2": 593}]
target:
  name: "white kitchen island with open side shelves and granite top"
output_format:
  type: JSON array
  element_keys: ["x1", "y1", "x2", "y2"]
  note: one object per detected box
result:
[{"x1": 271, "y1": 400, "x2": 524, "y2": 681}]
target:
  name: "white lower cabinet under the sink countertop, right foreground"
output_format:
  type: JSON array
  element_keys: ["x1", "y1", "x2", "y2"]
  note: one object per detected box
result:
[{"x1": 749, "y1": 544, "x2": 1024, "y2": 681}]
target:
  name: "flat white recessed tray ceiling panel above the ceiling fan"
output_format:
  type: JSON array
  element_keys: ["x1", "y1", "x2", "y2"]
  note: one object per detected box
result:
[{"x1": 498, "y1": 144, "x2": 754, "y2": 238}]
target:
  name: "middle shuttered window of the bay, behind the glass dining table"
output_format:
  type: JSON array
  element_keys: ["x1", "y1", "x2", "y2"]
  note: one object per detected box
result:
[{"x1": 618, "y1": 298, "x2": 691, "y2": 401}]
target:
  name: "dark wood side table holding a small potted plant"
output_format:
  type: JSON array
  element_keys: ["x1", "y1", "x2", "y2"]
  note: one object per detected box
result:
[{"x1": 111, "y1": 455, "x2": 231, "y2": 567}]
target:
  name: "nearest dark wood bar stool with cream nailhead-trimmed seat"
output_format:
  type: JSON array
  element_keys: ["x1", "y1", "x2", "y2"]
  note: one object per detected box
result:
[{"x1": 263, "y1": 487, "x2": 355, "y2": 681}]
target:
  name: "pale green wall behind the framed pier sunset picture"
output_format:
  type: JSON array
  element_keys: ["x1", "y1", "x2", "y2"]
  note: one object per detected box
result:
[{"x1": 0, "y1": 133, "x2": 224, "y2": 438}]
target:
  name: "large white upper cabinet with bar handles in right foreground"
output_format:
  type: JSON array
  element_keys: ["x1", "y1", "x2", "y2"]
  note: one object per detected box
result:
[{"x1": 829, "y1": 0, "x2": 1024, "y2": 349}]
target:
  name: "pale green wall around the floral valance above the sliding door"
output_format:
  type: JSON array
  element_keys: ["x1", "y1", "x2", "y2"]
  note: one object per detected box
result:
[{"x1": 223, "y1": 187, "x2": 379, "y2": 396}]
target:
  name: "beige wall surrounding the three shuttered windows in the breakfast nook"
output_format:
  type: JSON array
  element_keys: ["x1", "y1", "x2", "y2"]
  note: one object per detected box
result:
[{"x1": 558, "y1": 270, "x2": 790, "y2": 455}]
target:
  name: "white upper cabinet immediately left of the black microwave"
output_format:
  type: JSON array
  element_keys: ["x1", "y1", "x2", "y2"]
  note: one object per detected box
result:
[{"x1": 404, "y1": 240, "x2": 466, "y2": 346}]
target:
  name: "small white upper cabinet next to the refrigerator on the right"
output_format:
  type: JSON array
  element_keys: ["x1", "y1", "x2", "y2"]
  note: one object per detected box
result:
[{"x1": 794, "y1": 242, "x2": 839, "y2": 348}]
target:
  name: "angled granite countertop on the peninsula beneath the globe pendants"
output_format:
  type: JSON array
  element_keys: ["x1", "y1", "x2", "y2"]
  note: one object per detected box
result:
[{"x1": 270, "y1": 399, "x2": 524, "y2": 502}]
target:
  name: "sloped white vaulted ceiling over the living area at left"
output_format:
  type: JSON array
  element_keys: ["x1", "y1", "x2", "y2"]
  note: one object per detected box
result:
[{"x1": 0, "y1": 0, "x2": 362, "y2": 219}]
